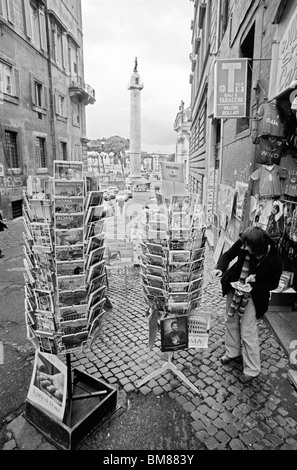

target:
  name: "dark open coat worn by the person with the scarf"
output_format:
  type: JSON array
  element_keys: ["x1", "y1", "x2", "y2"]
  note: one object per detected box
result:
[{"x1": 216, "y1": 238, "x2": 283, "y2": 318}]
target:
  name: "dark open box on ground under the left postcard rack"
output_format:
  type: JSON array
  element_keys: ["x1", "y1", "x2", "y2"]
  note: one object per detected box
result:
[{"x1": 25, "y1": 369, "x2": 117, "y2": 450}]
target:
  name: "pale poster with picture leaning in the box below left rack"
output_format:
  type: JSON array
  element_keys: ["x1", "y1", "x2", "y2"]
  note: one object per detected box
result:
[{"x1": 28, "y1": 350, "x2": 67, "y2": 421}]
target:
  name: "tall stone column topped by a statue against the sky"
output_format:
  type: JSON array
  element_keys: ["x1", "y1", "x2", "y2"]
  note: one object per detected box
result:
[{"x1": 128, "y1": 57, "x2": 143, "y2": 184}]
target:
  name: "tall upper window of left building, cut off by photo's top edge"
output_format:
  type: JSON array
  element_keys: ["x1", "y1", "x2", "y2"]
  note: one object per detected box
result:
[{"x1": 23, "y1": 0, "x2": 47, "y2": 51}]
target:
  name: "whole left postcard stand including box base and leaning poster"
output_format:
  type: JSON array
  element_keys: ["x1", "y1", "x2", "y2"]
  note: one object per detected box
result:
[{"x1": 23, "y1": 161, "x2": 117, "y2": 449}]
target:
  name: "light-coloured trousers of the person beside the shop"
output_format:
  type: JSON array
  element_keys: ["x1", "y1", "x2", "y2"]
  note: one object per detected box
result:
[{"x1": 225, "y1": 290, "x2": 261, "y2": 377}]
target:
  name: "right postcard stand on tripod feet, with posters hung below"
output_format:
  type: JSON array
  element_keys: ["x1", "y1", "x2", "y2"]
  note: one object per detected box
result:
[{"x1": 135, "y1": 194, "x2": 209, "y2": 395}]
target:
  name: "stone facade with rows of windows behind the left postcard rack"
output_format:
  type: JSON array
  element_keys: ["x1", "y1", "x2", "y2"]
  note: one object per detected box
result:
[{"x1": 0, "y1": 0, "x2": 95, "y2": 219}]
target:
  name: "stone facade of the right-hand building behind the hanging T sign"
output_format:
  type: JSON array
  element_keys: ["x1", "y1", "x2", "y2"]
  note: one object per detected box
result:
[{"x1": 189, "y1": 0, "x2": 297, "y2": 245}]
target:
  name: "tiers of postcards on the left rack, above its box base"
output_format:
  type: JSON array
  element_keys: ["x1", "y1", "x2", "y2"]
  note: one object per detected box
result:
[{"x1": 23, "y1": 160, "x2": 106, "y2": 354}]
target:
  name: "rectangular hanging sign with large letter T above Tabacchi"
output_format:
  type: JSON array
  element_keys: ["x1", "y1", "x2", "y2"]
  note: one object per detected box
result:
[{"x1": 214, "y1": 59, "x2": 248, "y2": 119}]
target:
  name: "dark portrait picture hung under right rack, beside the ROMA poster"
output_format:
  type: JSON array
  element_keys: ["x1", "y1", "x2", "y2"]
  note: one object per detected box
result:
[{"x1": 160, "y1": 315, "x2": 188, "y2": 352}]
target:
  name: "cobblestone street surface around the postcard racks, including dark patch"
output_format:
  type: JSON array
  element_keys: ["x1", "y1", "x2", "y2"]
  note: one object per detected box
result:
[{"x1": 1, "y1": 221, "x2": 297, "y2": 450}]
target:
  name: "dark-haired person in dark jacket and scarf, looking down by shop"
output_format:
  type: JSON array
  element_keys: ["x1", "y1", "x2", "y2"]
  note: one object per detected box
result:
[{"x1": 213, "y1": 227, "x2": 283, "y2": 383}]
